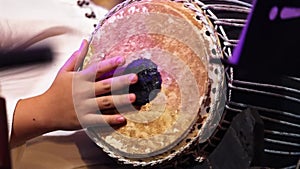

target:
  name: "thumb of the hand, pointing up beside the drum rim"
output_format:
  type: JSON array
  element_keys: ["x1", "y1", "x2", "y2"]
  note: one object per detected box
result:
[{"x1": 62, "y1": 39, "x2": 88, "y2": 71}]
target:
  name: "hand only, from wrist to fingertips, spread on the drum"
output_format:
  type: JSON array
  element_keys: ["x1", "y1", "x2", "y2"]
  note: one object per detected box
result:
[{"x1": 45, "y1": 40, "x2": 137, "y2": 130}]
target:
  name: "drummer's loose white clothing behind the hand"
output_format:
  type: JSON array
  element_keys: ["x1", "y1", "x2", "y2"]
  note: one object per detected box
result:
[{"x1": 0, "y1": 0, "x2": 107, "y2": 137}]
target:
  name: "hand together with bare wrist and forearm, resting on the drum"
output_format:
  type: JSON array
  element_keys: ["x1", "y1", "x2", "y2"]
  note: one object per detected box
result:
[{"x1": 11, "y1": 40, "x2": 137, "y2": 147}]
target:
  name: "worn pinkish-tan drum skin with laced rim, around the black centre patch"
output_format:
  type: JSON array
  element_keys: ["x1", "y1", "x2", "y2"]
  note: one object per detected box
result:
[{"x1": 77, "y1": 0, "x2": 225, "y2": 165}]
